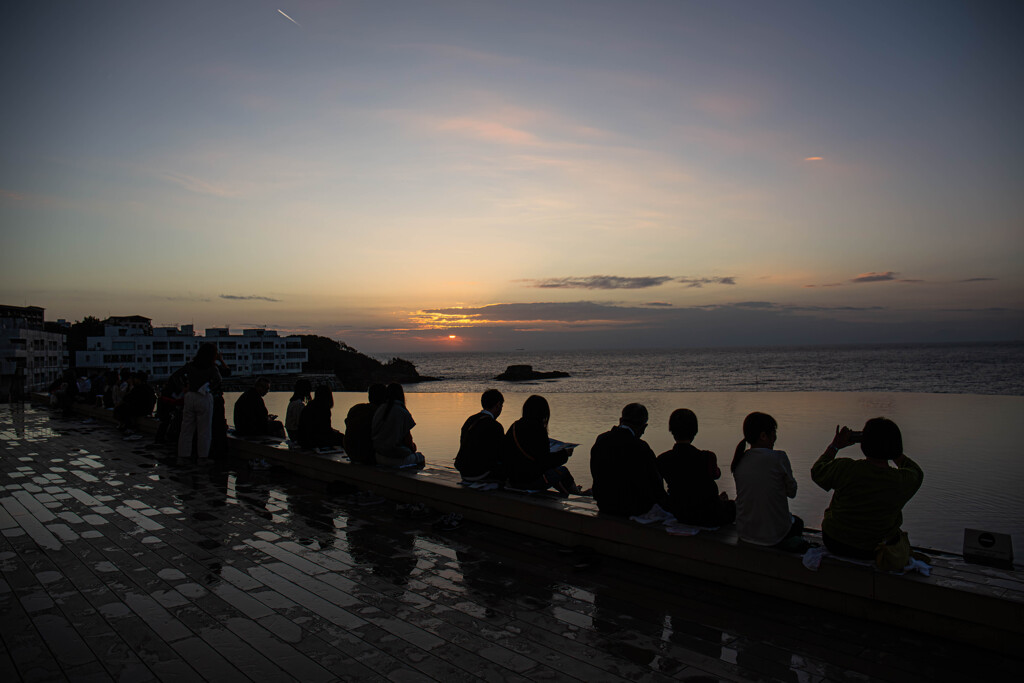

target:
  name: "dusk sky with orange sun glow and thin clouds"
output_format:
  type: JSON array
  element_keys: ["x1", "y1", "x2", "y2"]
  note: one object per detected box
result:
[{"x1": 0, "y1": 0, "x2": 1024, "y2": 352}]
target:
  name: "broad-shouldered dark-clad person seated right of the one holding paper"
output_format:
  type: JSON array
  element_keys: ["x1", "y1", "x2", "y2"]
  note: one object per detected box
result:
[{"x1": 590, "y1": 403, "x2": 666, "y2": 517}]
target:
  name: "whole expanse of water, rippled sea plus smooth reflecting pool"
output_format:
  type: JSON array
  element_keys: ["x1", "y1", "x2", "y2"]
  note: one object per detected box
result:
[{"x1": 225, "y1": 344, "x2": 1024, "y2": 552}]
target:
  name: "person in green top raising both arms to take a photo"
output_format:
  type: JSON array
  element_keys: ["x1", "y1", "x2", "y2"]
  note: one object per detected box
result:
[{"x1": 811, "y1": 418, "x2": 925, "y2": 559}]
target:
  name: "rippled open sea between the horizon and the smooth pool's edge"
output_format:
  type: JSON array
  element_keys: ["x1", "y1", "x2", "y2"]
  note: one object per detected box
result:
[{"x1": 389, "y1": 342, "x2": 1024, "y2": 396}]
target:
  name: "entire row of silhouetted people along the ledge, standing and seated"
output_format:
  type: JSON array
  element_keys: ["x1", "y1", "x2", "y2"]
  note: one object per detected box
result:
[{"x1": 56, "y1": 344, "x2": 924, "y2": 566}]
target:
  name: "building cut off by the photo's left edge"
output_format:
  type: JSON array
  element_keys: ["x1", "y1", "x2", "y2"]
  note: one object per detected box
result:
[{"x1": 0, "y1": 306, "x2": 68, "y2": 394}]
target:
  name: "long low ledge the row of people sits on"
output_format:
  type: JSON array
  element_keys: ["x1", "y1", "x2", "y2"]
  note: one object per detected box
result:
[{"x1": 41, "y1": 397, "x2": 1024, "y2": 656}]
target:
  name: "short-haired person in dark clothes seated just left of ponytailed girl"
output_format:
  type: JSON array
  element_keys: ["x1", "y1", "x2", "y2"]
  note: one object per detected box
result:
[{"x1": 657, "y1": 408, "x2": 736, "y2": 526}]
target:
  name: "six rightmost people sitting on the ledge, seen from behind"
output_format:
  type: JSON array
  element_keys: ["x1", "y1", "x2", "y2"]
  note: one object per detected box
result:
[{"x1": 456, "y1": 389, "x2": 924, "y2": 568}]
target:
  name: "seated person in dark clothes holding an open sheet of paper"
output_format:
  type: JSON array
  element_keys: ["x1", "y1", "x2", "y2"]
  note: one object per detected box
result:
[{"x1": 502, "y1": 394, "x2": 580, "y2": 496}]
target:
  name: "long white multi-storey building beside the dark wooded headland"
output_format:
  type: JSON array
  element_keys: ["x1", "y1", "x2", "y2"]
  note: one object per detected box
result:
[{"x1": 76, "y1": 325, "x2": 309, "y2": 380}]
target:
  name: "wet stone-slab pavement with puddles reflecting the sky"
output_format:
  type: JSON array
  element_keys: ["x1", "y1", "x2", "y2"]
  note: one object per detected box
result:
[{"x1": 0, "y1": 404, "x2": 1021, "y2": 683}]
